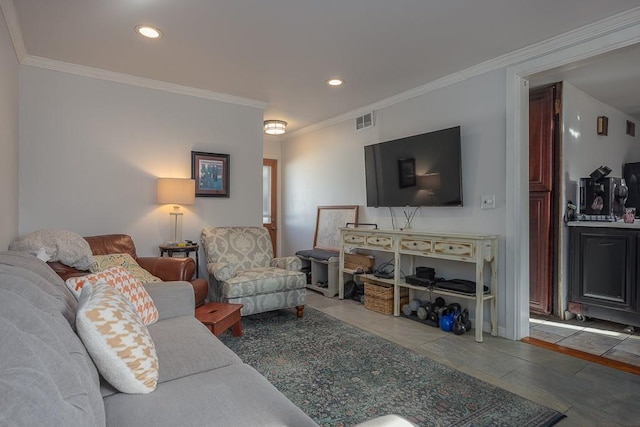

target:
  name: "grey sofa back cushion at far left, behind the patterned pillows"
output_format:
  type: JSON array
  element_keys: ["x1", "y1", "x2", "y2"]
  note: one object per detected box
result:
[{"x1": 0, "y1": 252, "x2": 105, "y2": 426}]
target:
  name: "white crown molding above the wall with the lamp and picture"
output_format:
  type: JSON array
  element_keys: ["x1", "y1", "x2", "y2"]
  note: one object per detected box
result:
[{"x1": 22, "y1": 55, "x2": 268, "y2": 109}]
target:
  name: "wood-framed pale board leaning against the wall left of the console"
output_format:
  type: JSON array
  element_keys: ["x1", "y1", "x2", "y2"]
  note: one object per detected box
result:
[{"x1": 313, "y1": 205, "x2": 358, "y2": 251}]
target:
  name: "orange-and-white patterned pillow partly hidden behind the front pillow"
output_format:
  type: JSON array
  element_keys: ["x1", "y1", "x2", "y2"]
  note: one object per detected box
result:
[{"x1": 65, "y1": 266, "x2": 158, "y2": 325}]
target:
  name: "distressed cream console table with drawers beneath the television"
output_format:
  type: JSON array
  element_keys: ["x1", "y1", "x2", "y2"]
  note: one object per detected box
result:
[{"x1": 338, "y1": 228, "x2": 498, "y2": 342}]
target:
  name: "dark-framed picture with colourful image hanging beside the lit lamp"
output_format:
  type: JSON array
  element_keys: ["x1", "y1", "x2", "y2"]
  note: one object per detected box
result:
[{"x1": 191, "y1": 151, "x2": 229, "y2": 197}]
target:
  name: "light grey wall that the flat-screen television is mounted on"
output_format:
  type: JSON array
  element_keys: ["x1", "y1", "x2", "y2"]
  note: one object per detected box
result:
[{"x1": 282, "y1": 71, "x2": 506, "y2": 332}]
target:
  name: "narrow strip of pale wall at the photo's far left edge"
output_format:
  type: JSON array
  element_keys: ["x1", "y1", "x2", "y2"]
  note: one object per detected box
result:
[{"x1": 0, "y1": 11, "x2": 19, "y2": 250}]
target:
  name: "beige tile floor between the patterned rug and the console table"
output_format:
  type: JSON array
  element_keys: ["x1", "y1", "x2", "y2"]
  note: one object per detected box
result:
[{"x1": 307, "y1": 291, "x2": 640, "y2": 427}]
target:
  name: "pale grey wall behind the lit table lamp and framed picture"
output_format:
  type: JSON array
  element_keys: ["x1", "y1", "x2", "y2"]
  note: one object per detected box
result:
[{"x1": 19, "y1": 66, "x2": 263, "y2": 270}]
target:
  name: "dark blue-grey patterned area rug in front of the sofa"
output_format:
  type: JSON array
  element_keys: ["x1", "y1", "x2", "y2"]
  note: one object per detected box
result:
[{"x1": 221, "y1": 307, "x2": 564, "y2": 427}]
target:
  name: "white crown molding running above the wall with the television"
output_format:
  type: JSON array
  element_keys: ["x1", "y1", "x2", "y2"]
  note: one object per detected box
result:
[{"x1": 282, "y1": 7, "x2": 640, "y2": 140}]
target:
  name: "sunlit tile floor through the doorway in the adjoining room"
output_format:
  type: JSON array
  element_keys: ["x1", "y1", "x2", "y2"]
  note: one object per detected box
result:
[{"x1": 529, "y1": 317, "x2": 640, "y2": 370}]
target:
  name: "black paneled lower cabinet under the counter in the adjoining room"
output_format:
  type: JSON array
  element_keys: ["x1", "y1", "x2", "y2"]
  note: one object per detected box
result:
[{"x1": 569, "y1": 226, "x2": 640, "y2": 326}]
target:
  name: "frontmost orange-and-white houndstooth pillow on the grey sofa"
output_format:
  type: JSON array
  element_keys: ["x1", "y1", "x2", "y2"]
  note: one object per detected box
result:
[{"x1": 76, "y1": 281, "x2": 158, "y2": 394}]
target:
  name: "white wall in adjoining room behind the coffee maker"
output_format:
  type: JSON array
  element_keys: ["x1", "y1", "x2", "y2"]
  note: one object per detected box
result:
[{"x1": 558, "y1": 82, "x2": 640, "y2": 314}]
